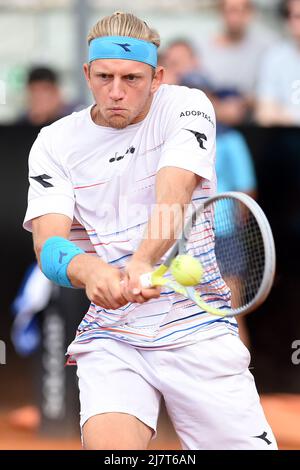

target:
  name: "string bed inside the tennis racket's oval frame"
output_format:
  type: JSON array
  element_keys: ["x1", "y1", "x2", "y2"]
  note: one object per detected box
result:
[{"x1": 186, "y1": 198, "x2": 265, "y2": 309}]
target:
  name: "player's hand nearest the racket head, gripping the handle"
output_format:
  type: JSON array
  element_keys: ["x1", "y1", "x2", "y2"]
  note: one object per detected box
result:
[{"x1": 122, "y1": 257, "x2": 160, "y2": 304}]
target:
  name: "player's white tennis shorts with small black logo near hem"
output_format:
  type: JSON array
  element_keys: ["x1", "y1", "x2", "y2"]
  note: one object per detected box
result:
[{"x1": 76, "y1": 334, "x2": 277, "y2": 450}]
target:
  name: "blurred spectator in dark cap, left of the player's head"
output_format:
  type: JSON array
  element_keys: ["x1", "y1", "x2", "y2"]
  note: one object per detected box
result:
[{"x1": 17, "y1": 67, "x2": 75, "y2": 126}]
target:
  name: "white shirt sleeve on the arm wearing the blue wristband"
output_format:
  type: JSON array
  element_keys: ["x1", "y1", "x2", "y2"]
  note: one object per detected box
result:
[{"x1": 23, "y1": 129, "x2": 75, "y2": 231}]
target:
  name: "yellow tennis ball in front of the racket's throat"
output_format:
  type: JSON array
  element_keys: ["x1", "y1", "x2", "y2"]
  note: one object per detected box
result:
[{"x1": 170, "y1": 255, "x2": 203, "y2": 286}]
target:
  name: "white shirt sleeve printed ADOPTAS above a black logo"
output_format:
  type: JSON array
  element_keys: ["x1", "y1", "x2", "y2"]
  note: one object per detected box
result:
[{"x1": 157, "y1": 89, "x2": 216, "y2": 181}]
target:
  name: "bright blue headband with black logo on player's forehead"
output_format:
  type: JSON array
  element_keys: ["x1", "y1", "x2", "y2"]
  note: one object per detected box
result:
[{"x1": 89, "y1": 36, "x2": 157, "y2": 67}]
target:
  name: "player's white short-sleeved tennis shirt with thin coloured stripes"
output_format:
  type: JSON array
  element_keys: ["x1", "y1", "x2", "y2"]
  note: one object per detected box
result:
[{"x1": 24, "y1": 85, "x2": 237, "y2": 355}]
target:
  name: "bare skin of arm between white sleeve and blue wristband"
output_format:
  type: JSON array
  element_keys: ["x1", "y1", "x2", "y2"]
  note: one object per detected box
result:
[{"x1": 32, "y1": 214, "x2": 72, "y2": 263}]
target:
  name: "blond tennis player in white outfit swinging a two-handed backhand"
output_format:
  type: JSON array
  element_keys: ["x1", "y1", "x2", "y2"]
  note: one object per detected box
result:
[{"x1": 24, "y1": 13, "x2": 276, "y2": 449}]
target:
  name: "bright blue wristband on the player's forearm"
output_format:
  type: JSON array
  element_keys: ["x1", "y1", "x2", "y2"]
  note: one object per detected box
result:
[{"x1": 40, "y1": 237, "x2": 84, "y2": 288}]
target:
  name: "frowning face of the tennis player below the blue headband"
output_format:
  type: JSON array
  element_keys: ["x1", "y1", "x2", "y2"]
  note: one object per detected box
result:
[{"x1": 84, "y1": 59, "x2": 163, "y2": 129}]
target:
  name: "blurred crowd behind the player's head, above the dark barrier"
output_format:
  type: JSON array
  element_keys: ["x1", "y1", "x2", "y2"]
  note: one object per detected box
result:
[{"x1": 0, "y1": 0, "x2": 300, "y2": 126}]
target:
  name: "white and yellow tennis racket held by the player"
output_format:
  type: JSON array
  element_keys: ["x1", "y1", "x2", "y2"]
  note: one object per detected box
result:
[{"x1": 140, "y1": 192, "x2": 276, "y2": 317}]
